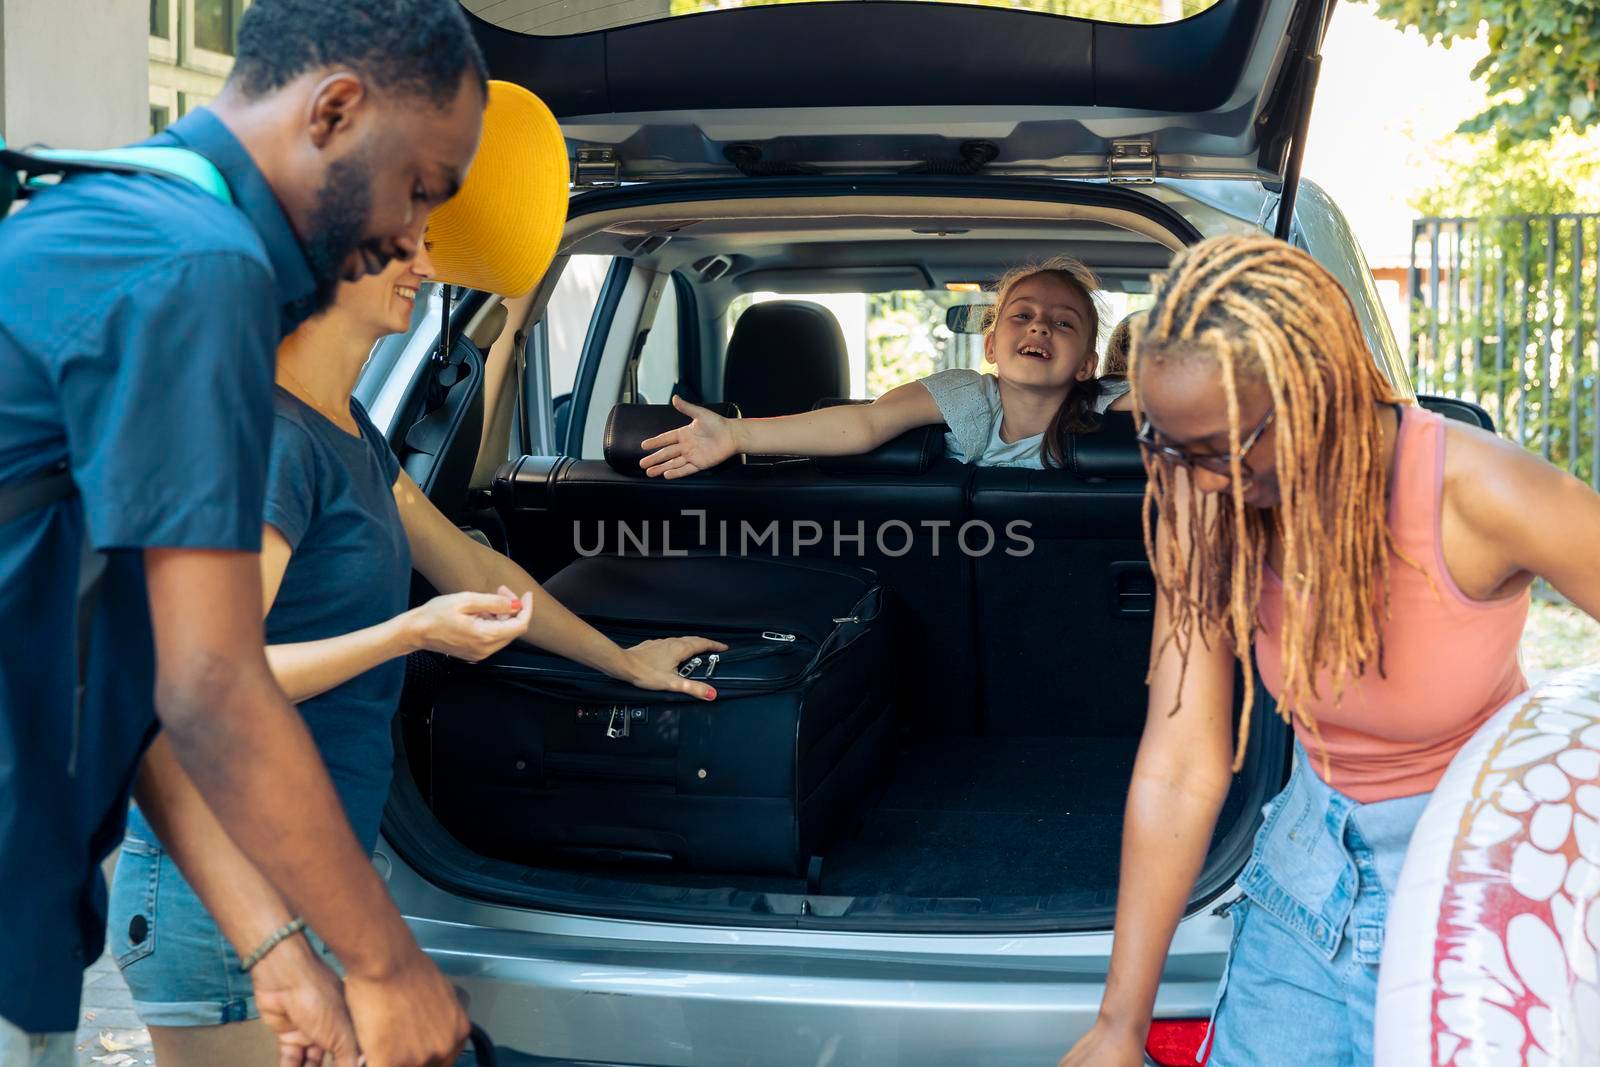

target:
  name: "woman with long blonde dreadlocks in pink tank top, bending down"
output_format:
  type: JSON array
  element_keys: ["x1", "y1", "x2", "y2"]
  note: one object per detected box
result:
[{"x1": 1061, "y1": 237, "x2": 1600, "y2": 1067}]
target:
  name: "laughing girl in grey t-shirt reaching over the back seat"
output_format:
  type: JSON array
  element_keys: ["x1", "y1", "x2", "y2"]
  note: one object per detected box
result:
[{"x1": 640, "y1": 258, "x2": 1139, "y2": 478}]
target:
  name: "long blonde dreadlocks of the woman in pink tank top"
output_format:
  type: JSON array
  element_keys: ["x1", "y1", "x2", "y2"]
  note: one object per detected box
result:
[{"x1": 1130, "y1": 237, "x2": 1403, "y2": 771}]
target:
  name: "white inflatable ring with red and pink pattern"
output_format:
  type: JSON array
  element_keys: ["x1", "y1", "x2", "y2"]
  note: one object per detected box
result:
[{"x1": 1376, "y1": 667, "x2": 1600, "y2": 1067}]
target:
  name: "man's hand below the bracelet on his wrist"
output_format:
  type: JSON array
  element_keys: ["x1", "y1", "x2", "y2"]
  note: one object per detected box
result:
[{"x1": 250, "y1": 936, "x2": 360, "y2": 1067}]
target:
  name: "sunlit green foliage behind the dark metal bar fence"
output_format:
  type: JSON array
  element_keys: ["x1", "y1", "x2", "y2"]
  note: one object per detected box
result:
[{"x1": 1411, "y1": 120, "x2": 1600, "y2": 482}]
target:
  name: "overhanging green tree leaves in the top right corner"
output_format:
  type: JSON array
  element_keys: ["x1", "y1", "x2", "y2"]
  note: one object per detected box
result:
[{"x1": 1378, "y1": 0, "x2": 1600, "y2": 147}]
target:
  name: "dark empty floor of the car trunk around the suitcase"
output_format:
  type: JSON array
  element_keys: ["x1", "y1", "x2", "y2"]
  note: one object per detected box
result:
[{"x1": 384, "y1": 671, "x2": 1286, "y2": 933}]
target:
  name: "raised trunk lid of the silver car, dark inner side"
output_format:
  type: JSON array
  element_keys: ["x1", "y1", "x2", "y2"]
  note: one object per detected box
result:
[{"x1": 462, "y1": 0, "x2": 1333, "y2": 187}]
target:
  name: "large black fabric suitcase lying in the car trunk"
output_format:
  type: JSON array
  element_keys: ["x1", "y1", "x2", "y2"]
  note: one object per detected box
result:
[{"x1": 430, "y1": 555, "x2": 894, "y2": 875}]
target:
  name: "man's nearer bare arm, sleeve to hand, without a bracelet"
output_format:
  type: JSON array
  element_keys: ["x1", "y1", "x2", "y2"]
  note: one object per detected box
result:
[{"x1": 144, "y1": 549, "x2": 467, "y2": 1067}]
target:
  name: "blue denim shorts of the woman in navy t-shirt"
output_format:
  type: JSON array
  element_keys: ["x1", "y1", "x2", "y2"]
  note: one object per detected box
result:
[{"x1": 106, "y1": 819, "x2": 336, "y2": 1027}]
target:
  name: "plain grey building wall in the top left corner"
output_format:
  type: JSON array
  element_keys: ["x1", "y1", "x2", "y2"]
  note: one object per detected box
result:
[{"x1": 0, "y1": 0, "x2": 149, "y2": 149}]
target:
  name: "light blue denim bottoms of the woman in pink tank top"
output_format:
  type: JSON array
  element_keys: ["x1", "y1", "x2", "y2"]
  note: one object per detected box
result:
[{"x1": 1202, "y1": 744, "x2": 1429, "y2": 1067}]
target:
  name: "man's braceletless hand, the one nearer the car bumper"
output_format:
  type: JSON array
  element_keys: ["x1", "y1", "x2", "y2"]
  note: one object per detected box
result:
[{"x1": 344, "y1": 949, "x2": 469, "y2": 1067}]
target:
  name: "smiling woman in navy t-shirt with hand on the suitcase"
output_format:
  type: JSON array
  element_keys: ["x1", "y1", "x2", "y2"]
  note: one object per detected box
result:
[{"x1": 109, "y1": 246, "x2": 725, "y2": 1067}]
